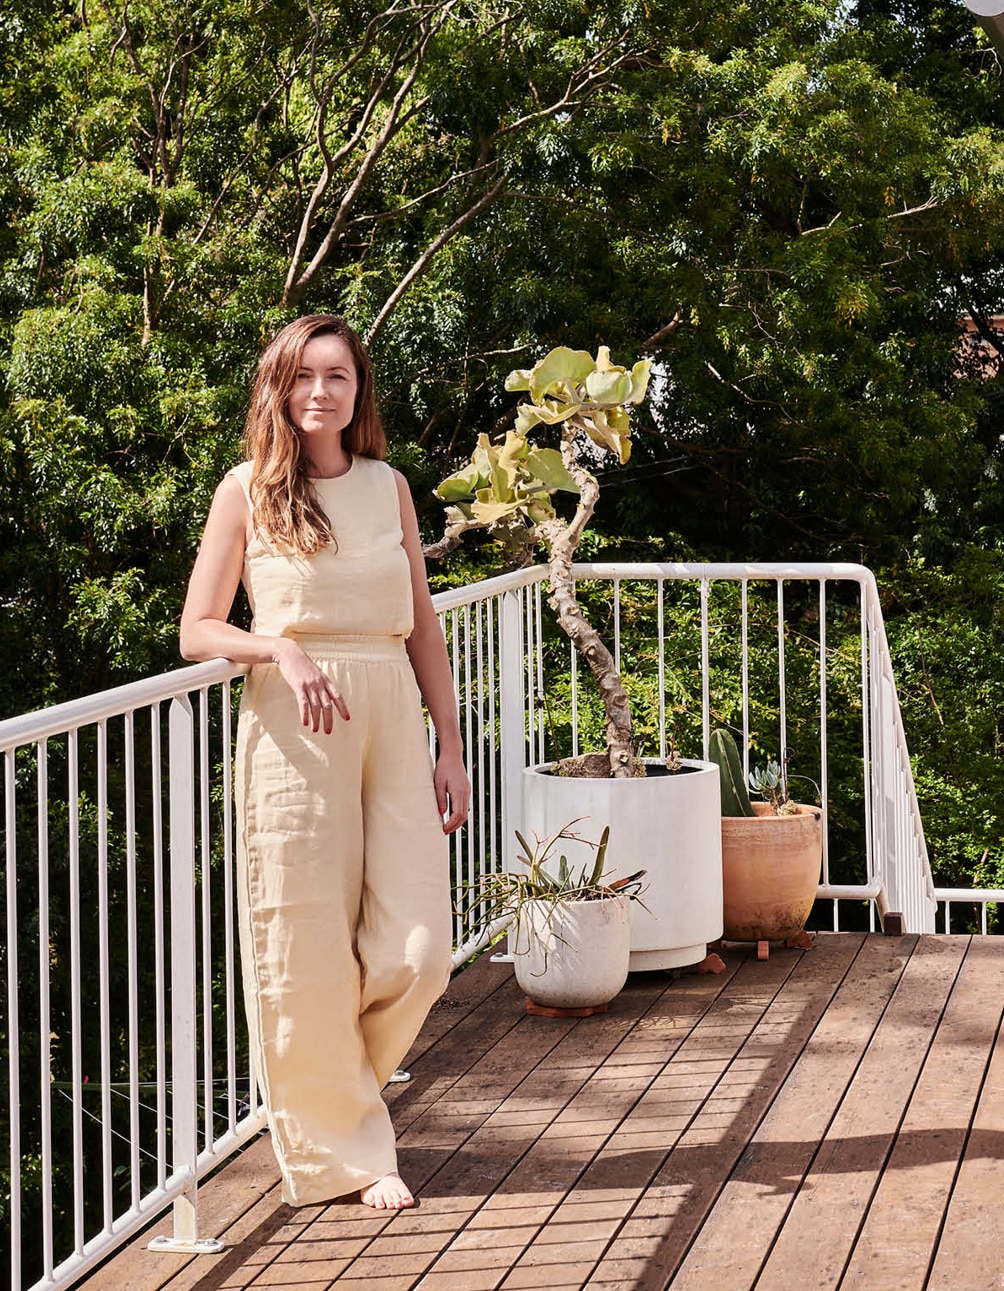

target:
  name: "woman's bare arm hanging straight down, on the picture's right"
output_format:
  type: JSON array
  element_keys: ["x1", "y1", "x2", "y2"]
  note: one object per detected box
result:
[{"x1": 394, "y1": 471, "x2": 471, "y2": 834}]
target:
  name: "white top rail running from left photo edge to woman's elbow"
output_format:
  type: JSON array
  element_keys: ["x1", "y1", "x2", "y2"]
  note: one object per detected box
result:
[{"x1": 0, "y1": 658, "x2": 245, "y2": 753}]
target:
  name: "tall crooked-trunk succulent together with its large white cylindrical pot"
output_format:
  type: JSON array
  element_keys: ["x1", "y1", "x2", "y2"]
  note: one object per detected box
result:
[{"x1": 427, "y1": 346, "x2": 721, "y2": 970}]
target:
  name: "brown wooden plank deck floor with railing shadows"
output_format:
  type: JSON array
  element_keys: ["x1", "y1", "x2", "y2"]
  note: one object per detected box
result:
[{"x1": 84, "y1": 933, "x2": 1004, "y2": 1291}]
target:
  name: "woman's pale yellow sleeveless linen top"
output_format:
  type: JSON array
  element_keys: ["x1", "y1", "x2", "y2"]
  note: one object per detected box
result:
[{"x1": 230, "y1": 457, "x2": 414, "y2": 636}]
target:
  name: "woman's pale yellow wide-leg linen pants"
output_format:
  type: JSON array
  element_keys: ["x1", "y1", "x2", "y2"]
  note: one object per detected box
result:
[{"x1": 236, "y1": 636, "x2": 452, "y2": 1206}]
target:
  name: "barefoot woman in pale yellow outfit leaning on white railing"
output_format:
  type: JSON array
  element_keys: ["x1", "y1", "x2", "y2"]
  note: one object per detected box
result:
[{"x1": 181, "y1": 315, "x2": 470, "y2": 1210}]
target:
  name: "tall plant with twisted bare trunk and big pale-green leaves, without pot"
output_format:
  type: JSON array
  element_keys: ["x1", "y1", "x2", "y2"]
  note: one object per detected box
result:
[{"x1": 426, "y1": 346, "x2": 652, "y2": 778}]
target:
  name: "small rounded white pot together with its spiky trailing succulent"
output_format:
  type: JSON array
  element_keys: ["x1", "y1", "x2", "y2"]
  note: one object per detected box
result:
[{"x1": 472, "y1": 820, "x2": 645, "y2": 1016}]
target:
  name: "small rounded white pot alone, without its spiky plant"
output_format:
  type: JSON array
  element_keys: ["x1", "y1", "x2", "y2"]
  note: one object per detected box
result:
[{"x1": 514, "y1": 896, "x2": 631, "y2": 1008}]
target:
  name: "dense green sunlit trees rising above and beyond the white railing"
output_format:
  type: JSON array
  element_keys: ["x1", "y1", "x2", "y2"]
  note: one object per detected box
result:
[{"x1": 0, "y1": 0, "x2": 1004, "y2": 884}]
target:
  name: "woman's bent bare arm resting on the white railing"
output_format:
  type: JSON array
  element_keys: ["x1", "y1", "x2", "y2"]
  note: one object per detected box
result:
[{"x1": 181, "y1": 475, "x2": 348, "y2": 733}]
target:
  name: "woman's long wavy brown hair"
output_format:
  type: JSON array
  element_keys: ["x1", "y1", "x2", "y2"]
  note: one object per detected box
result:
[{"x1": 244, "y1": 314, "x2": 387, "y2": 555}]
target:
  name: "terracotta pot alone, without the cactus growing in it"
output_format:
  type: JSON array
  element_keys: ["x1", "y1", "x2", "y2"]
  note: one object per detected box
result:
[{"x1": 721, "y1": 803, "x2": 822, "y2": 941}]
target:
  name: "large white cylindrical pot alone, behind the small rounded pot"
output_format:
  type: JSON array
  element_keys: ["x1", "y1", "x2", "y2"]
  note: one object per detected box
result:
[{"x1": 523, "y1": 759, "x2": 723, "y2": 972}]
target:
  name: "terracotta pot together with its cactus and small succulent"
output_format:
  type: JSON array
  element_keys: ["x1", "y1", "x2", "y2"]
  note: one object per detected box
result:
[{"x1": 710, "y1": 731, "x2": 822, "y2": 959}]
